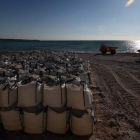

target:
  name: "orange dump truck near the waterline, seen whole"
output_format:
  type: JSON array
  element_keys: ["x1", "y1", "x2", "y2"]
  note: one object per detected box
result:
[{"x1": 100, "y1": 43, "x2": 118, "y2": 54}]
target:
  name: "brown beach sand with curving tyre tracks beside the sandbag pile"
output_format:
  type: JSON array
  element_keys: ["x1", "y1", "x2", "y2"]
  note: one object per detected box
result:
[{"x1": 0, "y1": 53, "x2": 140, "y2": 140}]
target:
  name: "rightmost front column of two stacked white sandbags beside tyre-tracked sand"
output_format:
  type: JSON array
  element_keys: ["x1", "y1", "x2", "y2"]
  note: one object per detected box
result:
[{"x1": 66, "y1": 83, "x2": 94, "y2": 136}]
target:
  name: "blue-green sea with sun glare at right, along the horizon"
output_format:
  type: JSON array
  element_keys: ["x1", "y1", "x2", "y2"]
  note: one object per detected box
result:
[{"x1": 0, "y1": 40, "x2": 140, "y2": 53}]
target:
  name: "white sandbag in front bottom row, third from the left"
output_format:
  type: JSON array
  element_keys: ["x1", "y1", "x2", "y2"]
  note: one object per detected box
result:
[{"x1": 46, "y1": 107, "x2": 69, "y2": 134}]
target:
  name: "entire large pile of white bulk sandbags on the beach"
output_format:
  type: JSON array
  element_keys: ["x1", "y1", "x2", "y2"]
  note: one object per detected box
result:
[{"x1": 0, "y1": 51, "x2": 94, "y2": 136}]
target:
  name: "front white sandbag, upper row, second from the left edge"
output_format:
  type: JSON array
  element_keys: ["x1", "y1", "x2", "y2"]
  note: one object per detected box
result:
[{"x1": 18, "y1": 81, "x2": 42, "y2": 107}]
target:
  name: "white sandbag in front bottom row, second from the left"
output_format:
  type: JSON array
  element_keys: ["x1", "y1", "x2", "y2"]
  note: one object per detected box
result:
[{"x1": 23, "y1": 105, "x2": 46, "y2": 134}]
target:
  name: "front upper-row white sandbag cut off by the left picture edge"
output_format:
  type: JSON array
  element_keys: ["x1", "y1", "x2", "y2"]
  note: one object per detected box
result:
[{"x1": 0, "y1": 83, "x2": 18, "y2": 107}]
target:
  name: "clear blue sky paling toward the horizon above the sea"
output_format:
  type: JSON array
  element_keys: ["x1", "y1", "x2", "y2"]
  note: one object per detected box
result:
[{"x1": 0, "y1": 0, "x2": 140, "y2": 40}]
